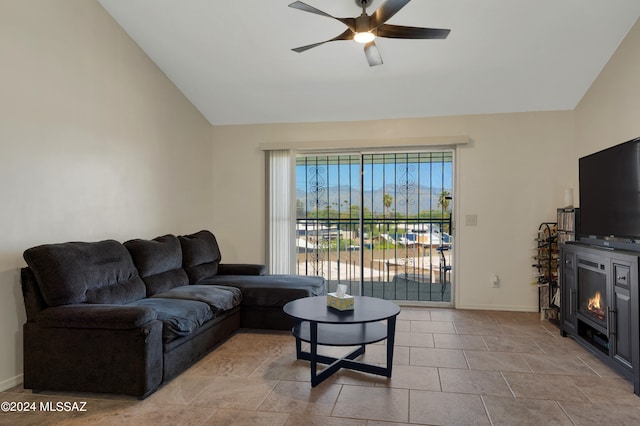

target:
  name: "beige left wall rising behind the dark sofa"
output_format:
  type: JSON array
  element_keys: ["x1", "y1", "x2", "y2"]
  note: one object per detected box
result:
[{"x1": 0, "y1": 0, "x2": 213, "y2": 389}]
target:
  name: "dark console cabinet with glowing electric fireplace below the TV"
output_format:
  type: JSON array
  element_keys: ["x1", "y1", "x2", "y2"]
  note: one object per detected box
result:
[{"x1": 560, "y1": 242, "x2": 640, "y2": 396}]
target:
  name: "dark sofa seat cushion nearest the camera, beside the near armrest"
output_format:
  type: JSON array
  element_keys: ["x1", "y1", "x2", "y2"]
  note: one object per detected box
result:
[{"x1": 127, "y1": 297, "x2": 213, "y2": 342}]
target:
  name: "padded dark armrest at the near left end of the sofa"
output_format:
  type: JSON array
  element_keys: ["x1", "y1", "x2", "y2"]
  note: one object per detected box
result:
[{"x1": 35, "y1": 305, "x2": 158, "y2": 330}]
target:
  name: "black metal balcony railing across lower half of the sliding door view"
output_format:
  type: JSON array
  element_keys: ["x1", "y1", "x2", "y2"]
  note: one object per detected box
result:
[{"x1": 296, "y1": 218, "x2": 453, "y2": 302}]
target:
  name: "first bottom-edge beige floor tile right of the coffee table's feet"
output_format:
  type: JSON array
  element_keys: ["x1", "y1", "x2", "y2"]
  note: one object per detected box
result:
[{"x1": 409, "y1": 390, "x2": 490, "y2": 425}]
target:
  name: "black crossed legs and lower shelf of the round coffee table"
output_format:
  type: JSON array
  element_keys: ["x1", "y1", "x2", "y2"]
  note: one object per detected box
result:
[{"x1": 292, "y1": 317, "x2": 396, "y2": 387}]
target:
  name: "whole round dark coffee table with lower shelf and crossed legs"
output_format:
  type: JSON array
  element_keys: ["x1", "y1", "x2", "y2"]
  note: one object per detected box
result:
[{"x1": 283, "y1": 296, "x2": 400, "y2": 387}]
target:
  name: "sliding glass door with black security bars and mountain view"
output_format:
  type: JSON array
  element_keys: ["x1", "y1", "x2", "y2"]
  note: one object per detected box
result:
[{"x1": 296, "y1": 151, "x2": 454, "y2": 304}]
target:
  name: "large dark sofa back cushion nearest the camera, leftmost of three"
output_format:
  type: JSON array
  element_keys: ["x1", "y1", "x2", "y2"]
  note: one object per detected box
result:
[{"x1": 23, "y1": 240, "x2": 146, "y2": 306}]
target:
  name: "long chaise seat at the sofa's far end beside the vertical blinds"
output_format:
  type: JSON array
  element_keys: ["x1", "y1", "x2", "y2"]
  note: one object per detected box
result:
[{"x1": 202, "y1": 275, "x2": 325, "y2": 307}]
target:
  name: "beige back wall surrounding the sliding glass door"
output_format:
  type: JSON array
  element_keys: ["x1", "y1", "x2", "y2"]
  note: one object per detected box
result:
[{"x1": 213, "y1": 111, "x2": 573, "y2": 311}]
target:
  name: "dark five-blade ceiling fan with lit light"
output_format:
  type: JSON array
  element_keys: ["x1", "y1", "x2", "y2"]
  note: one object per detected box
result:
[{"x1": 289, "y1": 0, "x2": 451, "y2": 67}]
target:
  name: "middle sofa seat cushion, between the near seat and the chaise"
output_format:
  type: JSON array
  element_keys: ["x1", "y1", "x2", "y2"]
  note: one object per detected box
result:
[{"x1": 154, "y1": 285, "x2": 242, "y2": 314}]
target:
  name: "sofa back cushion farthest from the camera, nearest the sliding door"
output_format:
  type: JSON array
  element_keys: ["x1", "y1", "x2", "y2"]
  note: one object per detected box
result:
[{"x1": 178, "y1": 231, "x2": 222, "y2": 284}]
